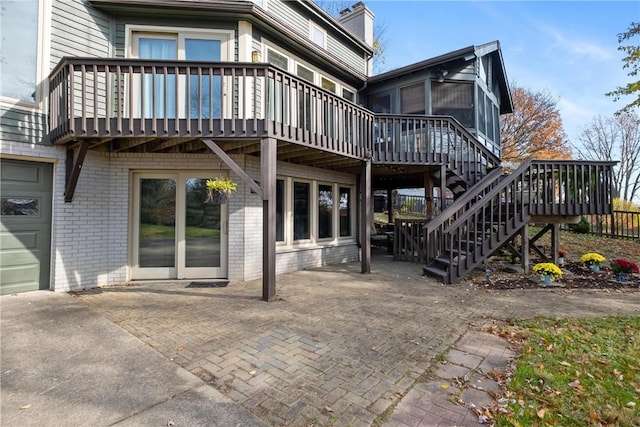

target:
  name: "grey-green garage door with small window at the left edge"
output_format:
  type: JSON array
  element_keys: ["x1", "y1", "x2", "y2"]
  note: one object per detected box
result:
[{"x1": 0, "y1": 159, "x2": 53, "y2": 294}]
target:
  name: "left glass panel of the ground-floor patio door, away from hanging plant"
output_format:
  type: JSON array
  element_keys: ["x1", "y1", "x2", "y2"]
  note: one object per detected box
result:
[{"x1": 136, "y1": 178, "x2": 176, "y2": 278}]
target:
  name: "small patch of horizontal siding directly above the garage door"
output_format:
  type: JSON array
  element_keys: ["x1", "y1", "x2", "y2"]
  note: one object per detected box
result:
[{"x1": 0, "y1": 105, "x2": 47, "y2": 144}]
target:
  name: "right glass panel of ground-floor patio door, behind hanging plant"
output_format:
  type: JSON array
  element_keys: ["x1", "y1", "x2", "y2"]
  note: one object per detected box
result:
[{"x1": 185, "y1": 178, "x2": 222, "y2": 268}]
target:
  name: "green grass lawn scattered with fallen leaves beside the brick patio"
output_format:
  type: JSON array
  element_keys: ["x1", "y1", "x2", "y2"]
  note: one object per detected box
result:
[{"x1": 496, "y1": 317, "x2": 640, "y2": 427}]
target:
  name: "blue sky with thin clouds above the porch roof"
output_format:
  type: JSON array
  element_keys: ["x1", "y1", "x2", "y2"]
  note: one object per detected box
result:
[{"x1": 365, "y1": 0, "x2": 640, "y2": 142}]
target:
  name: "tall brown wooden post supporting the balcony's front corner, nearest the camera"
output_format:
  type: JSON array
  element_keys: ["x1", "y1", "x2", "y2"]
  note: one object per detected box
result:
[{"x1": 260, "y1": 138, "x2": 278, "y2": 301}]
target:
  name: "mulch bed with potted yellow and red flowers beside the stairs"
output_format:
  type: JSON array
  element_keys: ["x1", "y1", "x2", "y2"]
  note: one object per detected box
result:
[{"x1": 464, "y1": 262, "x2": 640, "y2": 289}]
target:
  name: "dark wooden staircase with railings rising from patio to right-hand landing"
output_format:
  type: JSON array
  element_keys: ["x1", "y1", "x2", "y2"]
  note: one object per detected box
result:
[{"x1": 422, "y1": 160, "x2": 615, "y2": 283}]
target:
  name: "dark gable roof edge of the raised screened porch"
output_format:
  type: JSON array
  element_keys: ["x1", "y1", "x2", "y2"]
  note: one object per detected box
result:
[{"x1": 368, "y1": 40, "x2": 513, "y2": 114}]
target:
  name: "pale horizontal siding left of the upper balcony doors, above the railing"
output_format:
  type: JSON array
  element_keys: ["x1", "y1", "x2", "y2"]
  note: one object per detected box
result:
[{"x1": 51, "y1": 0, "x2": 110, "y2": 68}]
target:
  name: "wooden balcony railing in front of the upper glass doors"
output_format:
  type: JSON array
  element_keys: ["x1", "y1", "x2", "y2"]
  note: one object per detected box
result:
[{"x1": 49, "y1": 58, "x2": 373, "y2": 159}]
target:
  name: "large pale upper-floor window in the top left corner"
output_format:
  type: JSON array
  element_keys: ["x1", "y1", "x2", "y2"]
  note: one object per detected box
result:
[{"x1": 0, "y1": 0, "x2": 39, "y2": 102}]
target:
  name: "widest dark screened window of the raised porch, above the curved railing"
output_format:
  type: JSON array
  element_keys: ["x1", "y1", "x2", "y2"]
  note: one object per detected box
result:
[{"x1": 431, "y1": 81, "x2": 475, "y2": 128}]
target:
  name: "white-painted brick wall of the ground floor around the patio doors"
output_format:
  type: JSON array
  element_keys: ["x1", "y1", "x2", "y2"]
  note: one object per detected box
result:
[{"x1": 0, "y1": 141, "x2": 358, "y2": 291}]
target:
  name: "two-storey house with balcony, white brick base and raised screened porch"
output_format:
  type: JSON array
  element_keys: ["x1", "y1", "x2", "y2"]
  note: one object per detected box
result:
[{"x1": 0, "y1": 0, "x2": 610, "y2": 300}]
